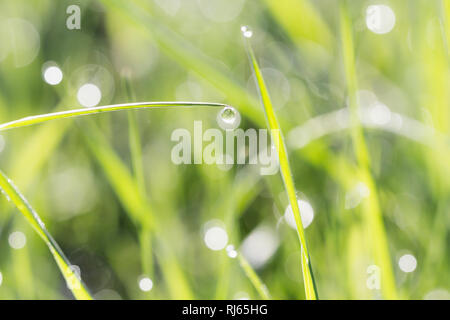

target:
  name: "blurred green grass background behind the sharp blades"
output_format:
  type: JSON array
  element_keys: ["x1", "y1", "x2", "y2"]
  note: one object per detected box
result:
[{"x1": 0, "y1": 0, "x2": 450, "y2": 299}]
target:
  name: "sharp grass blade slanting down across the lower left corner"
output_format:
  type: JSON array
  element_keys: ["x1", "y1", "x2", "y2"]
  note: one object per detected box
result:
[{"x1": 0, "y1": 171, "x2": 92, "y2": 300}]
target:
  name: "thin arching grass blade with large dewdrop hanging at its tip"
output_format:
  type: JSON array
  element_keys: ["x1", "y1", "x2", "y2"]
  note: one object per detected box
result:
[{"x1": 0, "y1": 102, "x2": 228, "y2": 131}]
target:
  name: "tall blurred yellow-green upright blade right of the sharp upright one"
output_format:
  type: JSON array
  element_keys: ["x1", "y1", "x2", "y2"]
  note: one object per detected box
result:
[{"x1": 340, "y1": 1, "x2": 397, "y2": 299}]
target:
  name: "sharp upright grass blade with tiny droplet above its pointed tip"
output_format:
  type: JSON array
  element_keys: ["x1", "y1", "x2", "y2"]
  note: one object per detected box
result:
[{"x1": 244, "y1": 36, "x2": 318, "y2": 300}]
